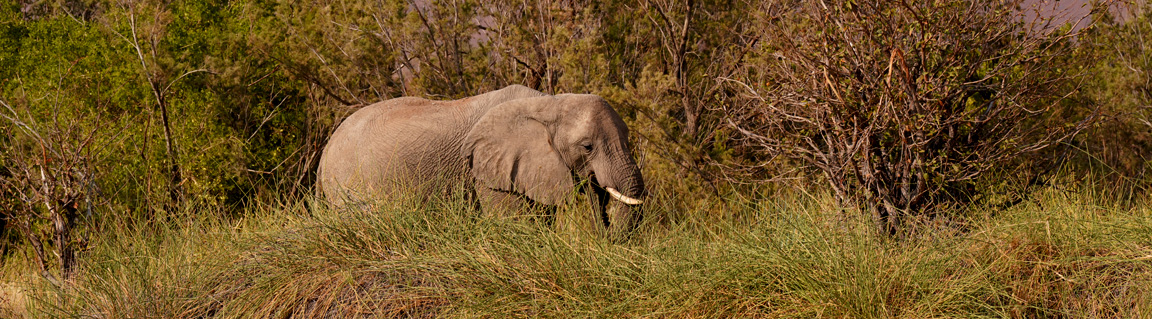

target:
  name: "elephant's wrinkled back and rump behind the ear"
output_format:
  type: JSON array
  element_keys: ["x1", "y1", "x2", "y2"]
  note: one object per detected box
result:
[{"x1": 317, "y1": 85, "x2": 545, "y2": 204}]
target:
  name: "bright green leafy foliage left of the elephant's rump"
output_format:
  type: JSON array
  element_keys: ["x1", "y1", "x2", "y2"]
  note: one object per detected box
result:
[{"x1": 0, "y1": 1, "x2": 332, "y2": 211}]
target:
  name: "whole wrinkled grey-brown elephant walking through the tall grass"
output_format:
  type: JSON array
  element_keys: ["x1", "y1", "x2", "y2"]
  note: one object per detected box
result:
[{"x1": 317, "y1": 85, "x2": 645, "y2": 234}]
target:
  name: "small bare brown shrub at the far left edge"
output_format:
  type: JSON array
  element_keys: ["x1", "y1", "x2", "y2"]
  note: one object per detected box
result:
[{"x1": 0, "y1": 85, "x2": 113, "y2": 280}]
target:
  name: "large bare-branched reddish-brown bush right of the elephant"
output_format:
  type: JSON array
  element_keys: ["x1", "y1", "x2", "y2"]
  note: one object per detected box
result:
[{"x1": 723, "y1": 0, "x2": 1091, "y2": 234}]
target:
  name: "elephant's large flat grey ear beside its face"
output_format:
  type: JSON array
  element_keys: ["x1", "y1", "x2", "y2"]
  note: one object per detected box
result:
[{"x1": 461, "y1": 97, "x2": 575, "y2": 205}]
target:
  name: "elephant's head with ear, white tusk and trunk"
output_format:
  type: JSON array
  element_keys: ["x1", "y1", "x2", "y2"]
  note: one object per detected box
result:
[{"x1": 461, "y1": 94, "x2": 645, "y2": 233}]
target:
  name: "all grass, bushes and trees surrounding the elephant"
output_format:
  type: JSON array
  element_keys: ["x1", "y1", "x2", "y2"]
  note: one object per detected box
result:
[{"x1": 0, "y1": 0, "x2": 1152, "y2": 318}]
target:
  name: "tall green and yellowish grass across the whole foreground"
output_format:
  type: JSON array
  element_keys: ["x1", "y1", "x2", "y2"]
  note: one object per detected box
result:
[{"x1": 0, "y1": 181, "x2": 1152, "y2": 318}]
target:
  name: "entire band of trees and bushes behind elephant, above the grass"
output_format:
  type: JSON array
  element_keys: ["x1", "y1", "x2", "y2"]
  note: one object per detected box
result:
[{"x1": 0, "y1": 0, "x2": 1152, "y2": 286}]
